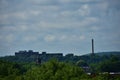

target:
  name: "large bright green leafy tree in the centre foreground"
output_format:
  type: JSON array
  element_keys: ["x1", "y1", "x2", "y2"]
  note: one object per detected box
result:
[{"x1": 24, "y1": 60, "x2": 85, "y2": 80}]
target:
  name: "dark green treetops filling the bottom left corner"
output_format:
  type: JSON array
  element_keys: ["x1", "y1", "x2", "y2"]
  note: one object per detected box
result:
[{"x1": 0, "y1": 60, "x2": 24, "y2": 80}]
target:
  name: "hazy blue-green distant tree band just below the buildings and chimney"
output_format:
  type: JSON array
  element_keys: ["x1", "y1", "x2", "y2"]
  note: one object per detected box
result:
[{"x1": 0, "y1": 52, "x2": 120, "y2": 64}]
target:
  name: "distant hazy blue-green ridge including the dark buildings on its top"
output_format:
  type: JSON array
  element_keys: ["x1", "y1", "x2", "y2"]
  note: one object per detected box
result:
[{"x1": 0, "y1": 51, "x2": 120, "y2": 64}]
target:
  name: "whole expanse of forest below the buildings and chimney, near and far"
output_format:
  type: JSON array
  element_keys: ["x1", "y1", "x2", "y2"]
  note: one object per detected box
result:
[{"x1": 0, "y1": 51, "x2": 120, "y2": 80}]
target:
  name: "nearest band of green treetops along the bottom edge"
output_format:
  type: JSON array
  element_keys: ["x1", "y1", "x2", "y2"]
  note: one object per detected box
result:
[{"x1": 0, "y1": 59, "x2": 120, "y2": 80}]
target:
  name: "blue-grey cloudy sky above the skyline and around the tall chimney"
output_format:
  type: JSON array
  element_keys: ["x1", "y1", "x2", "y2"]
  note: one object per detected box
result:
[{"x1": 0, "y1": 0, "x2": 120, "y2": 56}]
